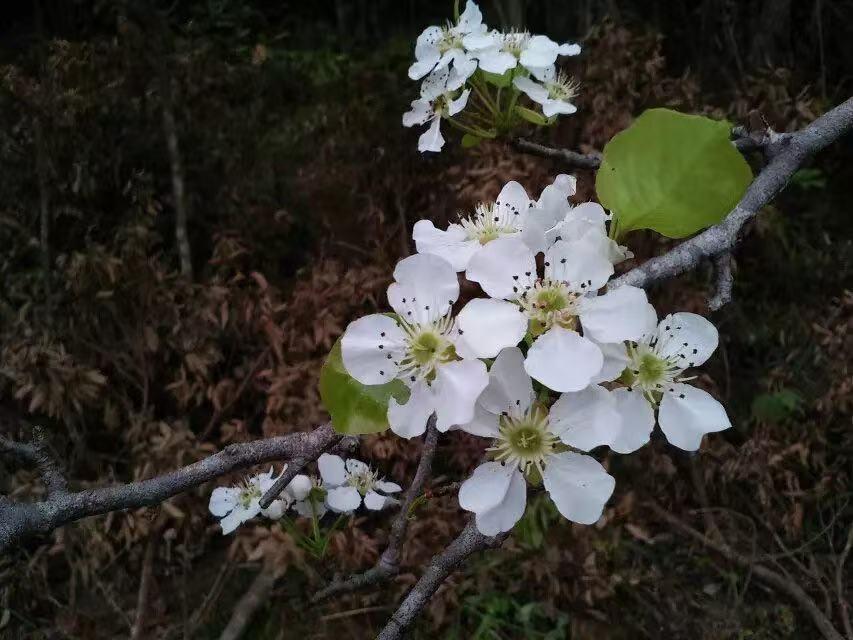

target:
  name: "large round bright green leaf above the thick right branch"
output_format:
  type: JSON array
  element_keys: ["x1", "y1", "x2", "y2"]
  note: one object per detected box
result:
[{"x1": 595, "y1": 109, "x2": 752, "y2": 238}]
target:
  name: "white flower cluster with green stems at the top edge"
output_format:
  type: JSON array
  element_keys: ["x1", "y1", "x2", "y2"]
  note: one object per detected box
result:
[{"x1": 403, "y1": 0, "x2": 581, "y2": 152}]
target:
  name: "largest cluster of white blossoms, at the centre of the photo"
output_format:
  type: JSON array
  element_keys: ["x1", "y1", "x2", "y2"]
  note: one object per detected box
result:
[{"x1": 340, "y1": 175, "x2": 731, "y2": 535}]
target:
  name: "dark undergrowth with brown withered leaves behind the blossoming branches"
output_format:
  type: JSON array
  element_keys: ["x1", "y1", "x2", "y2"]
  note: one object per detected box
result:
[{"x1": 0, "y1": 0, "x2": 853, "y2": 640}]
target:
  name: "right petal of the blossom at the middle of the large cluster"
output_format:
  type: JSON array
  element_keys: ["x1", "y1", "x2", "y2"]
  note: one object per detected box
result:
[{"x1": 580, "y1": 286, "x2": 649, "y2": 342}]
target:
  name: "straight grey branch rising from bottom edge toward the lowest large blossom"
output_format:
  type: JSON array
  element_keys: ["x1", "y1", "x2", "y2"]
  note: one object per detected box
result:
[{"x1": 376, "y1": 518, "x2": 508, "y2": 640}]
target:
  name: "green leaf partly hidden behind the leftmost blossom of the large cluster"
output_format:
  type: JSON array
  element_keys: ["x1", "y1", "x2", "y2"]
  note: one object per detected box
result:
[{"x1": 320, "y1": 338, "x2": 409, "y2": 434}]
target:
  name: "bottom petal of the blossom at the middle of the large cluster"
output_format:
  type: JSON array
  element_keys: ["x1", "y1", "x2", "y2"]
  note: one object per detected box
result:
[{"x1": 524, "y1": 327, "x2": 604, "y2": 391}]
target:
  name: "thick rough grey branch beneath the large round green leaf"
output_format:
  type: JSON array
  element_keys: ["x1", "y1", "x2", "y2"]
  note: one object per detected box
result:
[{"x1": 610, "y1": 98, "x2": 853, "y2": 288}]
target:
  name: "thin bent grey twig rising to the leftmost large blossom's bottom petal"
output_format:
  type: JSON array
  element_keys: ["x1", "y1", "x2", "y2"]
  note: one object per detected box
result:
[{"x1": 311, "y1": 415, "x2": 439, "y2": 602}]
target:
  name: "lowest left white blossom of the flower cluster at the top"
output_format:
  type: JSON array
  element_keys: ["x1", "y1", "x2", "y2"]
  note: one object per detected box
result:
[{"x1": 403, "y1": 67, "x2": 471, "y2": 152}]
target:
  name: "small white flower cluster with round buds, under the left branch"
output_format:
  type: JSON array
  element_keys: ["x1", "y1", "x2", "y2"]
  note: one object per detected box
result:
[{"x1": 208, "y1": 453, "x2": 401, "y2": 534}]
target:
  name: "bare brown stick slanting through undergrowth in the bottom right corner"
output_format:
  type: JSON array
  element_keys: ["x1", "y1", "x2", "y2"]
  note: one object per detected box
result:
[{"x1": 646, "y1": 502, "x2": 844, "y2": 640}]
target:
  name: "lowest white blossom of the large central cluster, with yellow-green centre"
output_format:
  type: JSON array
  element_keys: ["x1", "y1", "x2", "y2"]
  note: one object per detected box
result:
[{"x1": 459, "y1": 348, "x2": 619, "y2": 535}]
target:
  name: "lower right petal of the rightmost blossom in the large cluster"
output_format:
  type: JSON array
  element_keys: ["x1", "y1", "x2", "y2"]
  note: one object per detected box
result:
[{"x1": 658, "y1": 384, "x2": 732, "y2": 451}]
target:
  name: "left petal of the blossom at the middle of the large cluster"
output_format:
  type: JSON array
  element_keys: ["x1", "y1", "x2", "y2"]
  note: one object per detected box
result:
[{"x1": 457, "y1": 298, "x2": 527, "y2": 358}]
